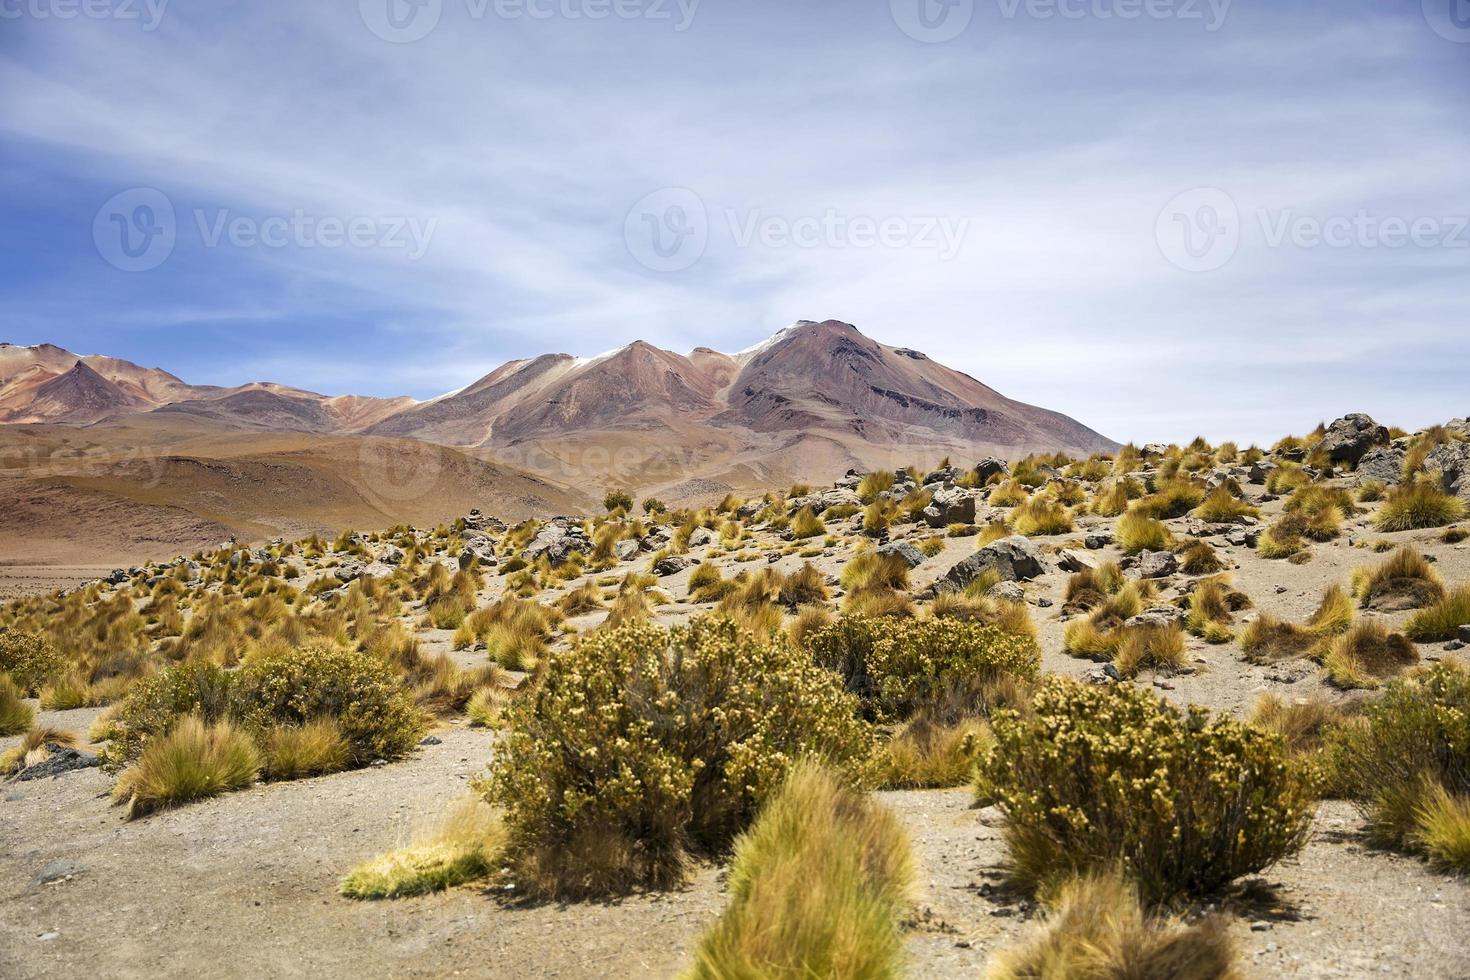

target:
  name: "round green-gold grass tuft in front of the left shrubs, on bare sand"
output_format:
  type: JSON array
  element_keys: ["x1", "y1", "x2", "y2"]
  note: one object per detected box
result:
[{"x1": 112, "y1": 716, "x2": 260, "y2": 820}]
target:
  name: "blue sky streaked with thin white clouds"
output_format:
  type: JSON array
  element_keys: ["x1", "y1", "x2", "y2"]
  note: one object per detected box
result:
[{"x1": 0, "y1": 0, "x2": 1470, "y2": 442}]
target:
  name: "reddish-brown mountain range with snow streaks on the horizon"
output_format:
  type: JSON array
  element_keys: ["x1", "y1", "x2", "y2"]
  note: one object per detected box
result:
[{"x1": 0, "y1": 320, "x2": 1116, "y2": 491}]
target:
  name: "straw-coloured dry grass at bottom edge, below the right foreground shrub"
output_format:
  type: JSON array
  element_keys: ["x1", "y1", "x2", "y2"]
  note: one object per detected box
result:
[{"x1": 985, "y1": 871, "x2": 1244, "y2": 980}]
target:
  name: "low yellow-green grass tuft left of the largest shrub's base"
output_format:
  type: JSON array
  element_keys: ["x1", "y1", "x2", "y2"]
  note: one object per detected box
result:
[{"x1": 338, "y1": 796, "x2": 504, "y2": 899}]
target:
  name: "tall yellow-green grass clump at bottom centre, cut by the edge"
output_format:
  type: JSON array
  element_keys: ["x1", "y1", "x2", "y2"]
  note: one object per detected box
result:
[{"x1": 688, "y1": 764, "x2": 914, "y2": 980}]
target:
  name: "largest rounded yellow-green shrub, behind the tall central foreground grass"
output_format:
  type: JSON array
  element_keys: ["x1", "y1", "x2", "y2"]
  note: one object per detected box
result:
[{"x1": 484, "y1": 619, "x2": 872, "y2": 896}]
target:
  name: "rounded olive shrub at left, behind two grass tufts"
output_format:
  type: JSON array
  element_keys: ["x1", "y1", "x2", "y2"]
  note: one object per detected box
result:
[{"x1": 231, "y1": 644, "x2": 423, "y2": 767}]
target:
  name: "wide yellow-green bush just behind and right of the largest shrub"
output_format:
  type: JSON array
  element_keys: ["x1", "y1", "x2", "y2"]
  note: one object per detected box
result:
[{"x1": 809, "y1": 616, "x2": 1041, "y2": 721}]
